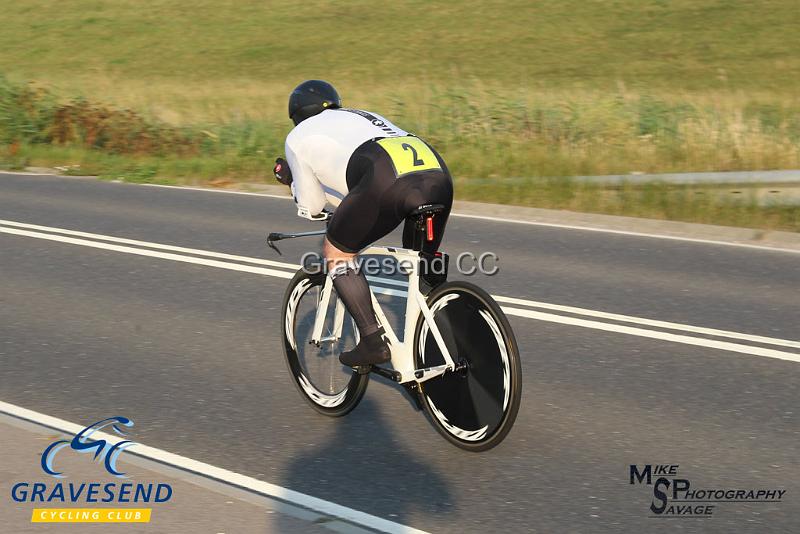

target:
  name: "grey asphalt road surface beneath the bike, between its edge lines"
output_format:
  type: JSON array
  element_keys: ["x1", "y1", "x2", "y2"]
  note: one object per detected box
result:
[{"x1": 0, "y1": 175, "x2": 800, "y2": 532}]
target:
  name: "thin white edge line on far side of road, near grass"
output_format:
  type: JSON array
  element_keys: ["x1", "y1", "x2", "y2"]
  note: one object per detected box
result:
[{"x1": 130, "y1": 184, "x2": 800, "y2": 254}]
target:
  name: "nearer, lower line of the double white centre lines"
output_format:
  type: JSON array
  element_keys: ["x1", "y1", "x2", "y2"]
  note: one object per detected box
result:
[{"x1": 0, "y1": 220, "x2": 800, "y2": 362}]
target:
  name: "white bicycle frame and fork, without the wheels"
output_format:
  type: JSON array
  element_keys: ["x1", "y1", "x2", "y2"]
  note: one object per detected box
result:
[{"x1": 310, "y1": 246, "x2": 456, "y2": 384}]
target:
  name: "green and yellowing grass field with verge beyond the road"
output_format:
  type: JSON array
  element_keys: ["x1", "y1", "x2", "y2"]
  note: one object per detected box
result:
[{"x1": 0, "y1": 0, "x2": 800, "y2": 229}]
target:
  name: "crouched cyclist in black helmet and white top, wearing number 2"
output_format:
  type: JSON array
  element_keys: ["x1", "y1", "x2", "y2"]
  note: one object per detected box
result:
[{"x1": 274, "y1": 80, "x2": 453, "y2": 367}]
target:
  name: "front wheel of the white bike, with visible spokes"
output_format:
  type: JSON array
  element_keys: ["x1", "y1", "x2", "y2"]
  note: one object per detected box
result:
[{"x1": 281, "y1": 270, "x2": 369, "y2": 417}]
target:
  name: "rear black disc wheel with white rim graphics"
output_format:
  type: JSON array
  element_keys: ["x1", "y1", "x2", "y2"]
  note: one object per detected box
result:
[{"x1": 414, "y1": 282, "x2": 522, "y2": 451}]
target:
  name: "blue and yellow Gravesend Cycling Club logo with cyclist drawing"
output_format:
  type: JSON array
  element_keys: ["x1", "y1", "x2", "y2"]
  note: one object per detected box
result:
[{"x1": 11, "y1": 416, "x2": 172, "y2": 523}]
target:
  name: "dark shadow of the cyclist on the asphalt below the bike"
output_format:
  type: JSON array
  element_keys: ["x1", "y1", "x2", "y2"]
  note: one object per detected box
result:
[{"x1": 285, "y1": 398, "x2": 453, "y2": 523}]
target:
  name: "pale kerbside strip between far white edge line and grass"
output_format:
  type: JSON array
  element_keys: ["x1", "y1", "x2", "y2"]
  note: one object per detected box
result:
[{"x1": 0, "y1": 169, "x2": 800, "y2": 251}]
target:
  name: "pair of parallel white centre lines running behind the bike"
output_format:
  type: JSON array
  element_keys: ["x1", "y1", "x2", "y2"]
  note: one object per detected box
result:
[{"x1": 0, "y1": 221, "x2": 800, "y2": 362}]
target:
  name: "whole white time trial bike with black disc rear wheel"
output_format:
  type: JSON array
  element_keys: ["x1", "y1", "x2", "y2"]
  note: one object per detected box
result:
[{"x1": 268, "y1": 204, "x2": 522, "y2": 451}]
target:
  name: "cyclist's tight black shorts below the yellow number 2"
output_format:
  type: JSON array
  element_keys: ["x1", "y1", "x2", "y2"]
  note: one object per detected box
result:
[{"x1": 327, "y1": 140, "x2": 453, "y2": 253}]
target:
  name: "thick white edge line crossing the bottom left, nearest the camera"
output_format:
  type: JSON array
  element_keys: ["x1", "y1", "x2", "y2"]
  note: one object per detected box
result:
[{"x1": 0, "y1": 401, "x2": 426, "y2": 534}]
